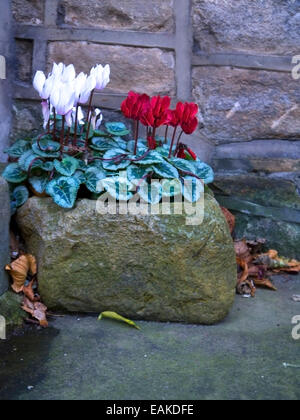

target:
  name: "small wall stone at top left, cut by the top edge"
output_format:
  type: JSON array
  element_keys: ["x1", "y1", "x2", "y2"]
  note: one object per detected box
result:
[{"x1": 12, "y1": 0, "x2": 44, "y2": 25}]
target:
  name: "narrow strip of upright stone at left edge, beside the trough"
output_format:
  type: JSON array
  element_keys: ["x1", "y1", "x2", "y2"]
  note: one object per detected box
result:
[{"x1": 0, "y1": 177, "x2": 10, "y2": 296}]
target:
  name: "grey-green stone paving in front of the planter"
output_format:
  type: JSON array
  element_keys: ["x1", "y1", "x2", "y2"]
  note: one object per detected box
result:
[{"x1": 0, "y1": 276, "x2": 300, "y2": 400}]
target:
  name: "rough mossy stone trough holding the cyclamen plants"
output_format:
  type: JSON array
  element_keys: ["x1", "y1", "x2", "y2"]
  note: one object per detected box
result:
[{"x1": 17, "y1": 195, "x2": 236, "y2": 324}]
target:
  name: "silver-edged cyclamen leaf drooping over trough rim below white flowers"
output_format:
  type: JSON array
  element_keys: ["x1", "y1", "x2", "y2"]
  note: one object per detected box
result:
[{"x1": 46, "y1": 176, "x2": 80, "y2": 209}]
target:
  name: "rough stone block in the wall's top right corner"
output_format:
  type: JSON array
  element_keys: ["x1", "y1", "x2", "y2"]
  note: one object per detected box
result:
[{"x1": 193, "y1": 0, "x2": 300, "y2": 55}]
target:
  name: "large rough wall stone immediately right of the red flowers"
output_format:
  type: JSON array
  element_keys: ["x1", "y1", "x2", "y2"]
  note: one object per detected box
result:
[{"x1": 193, "y1": 67, "x2": 300, "y2": 144}]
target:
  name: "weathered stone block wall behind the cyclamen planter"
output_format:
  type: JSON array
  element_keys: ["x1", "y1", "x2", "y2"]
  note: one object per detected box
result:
[{"x1": 5, "y1": 0, "x2": 300, "y2": 256}]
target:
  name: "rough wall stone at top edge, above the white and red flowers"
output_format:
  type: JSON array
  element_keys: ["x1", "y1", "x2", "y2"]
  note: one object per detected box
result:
[{"x1": 59, "y1": 0, "x2": 175, "y2": 32}]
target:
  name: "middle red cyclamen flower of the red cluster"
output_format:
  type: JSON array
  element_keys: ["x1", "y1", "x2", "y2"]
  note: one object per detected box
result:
[{"x1": 140, "y1": 96, "x2": 171, "y2": 128}]
